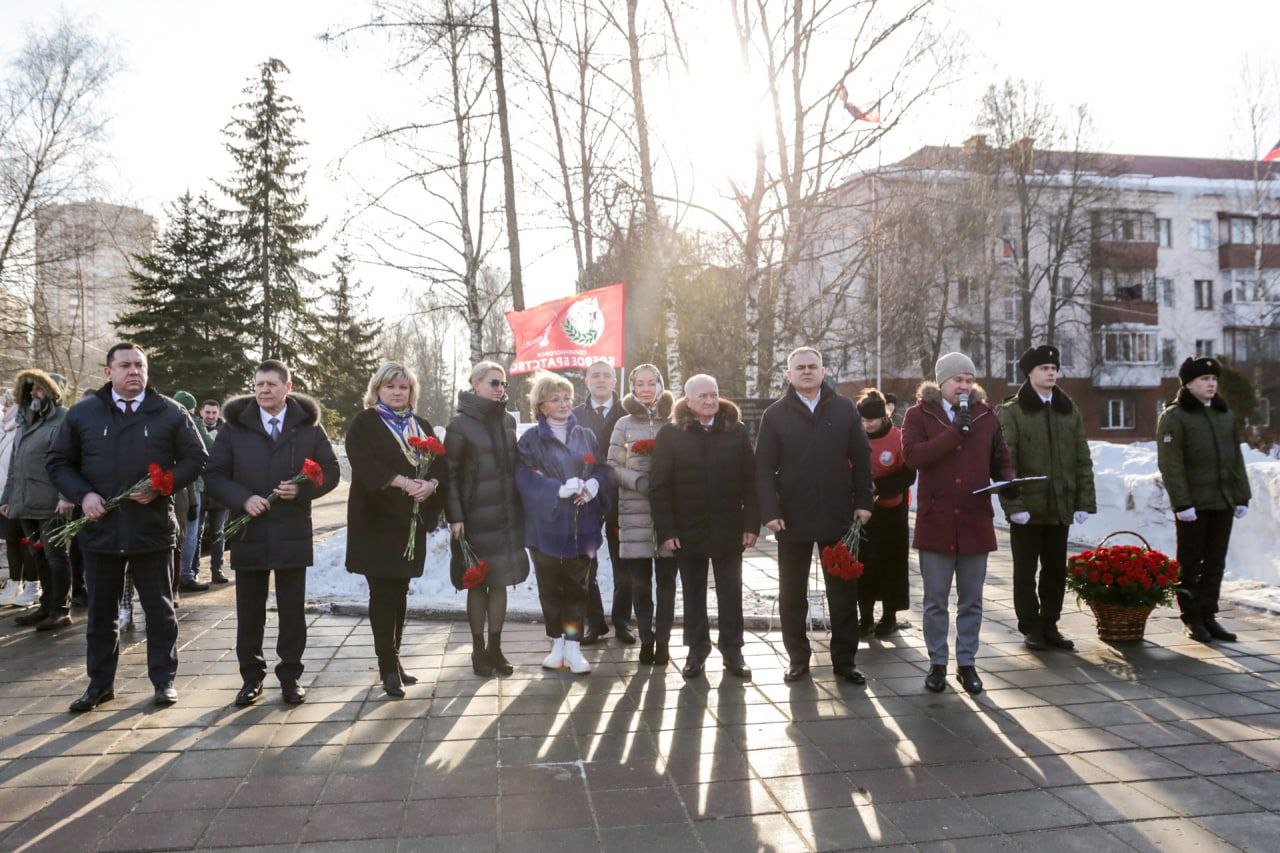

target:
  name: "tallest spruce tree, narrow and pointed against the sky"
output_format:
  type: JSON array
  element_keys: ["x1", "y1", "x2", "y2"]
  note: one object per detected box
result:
[{"x1": 223, "y1": 59, "x2": 320, "y2": 369}]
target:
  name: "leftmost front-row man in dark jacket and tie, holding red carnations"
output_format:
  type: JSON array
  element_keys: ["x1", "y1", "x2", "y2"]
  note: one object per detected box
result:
[{"x1": 46, "y1": 343, "x2": 209, "y2": 713}]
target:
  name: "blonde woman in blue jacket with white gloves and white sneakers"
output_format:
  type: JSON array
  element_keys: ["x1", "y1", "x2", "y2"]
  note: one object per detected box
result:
[{"x1": 516, "y1": 373, "x2": 612, "y2": 675}]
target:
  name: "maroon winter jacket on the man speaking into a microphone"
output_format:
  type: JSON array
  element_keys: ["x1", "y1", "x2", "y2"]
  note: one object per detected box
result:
[{"x1": 902, "y1": 382, "x2": 1015, "y2": 555}]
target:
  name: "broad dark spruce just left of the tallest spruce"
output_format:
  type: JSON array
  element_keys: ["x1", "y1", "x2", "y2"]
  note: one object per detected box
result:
[{"x1": 115, "y1": 192, "x2": 251, "y2": 400}]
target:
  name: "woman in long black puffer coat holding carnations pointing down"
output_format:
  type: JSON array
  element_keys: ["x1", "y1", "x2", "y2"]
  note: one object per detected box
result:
[{"x1": 444, "y1": 361, "x2": 529, "y2": 675}]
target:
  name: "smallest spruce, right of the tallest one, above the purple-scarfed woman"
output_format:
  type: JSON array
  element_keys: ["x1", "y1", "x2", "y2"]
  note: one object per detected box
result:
[{"x1": 310, "y1": 252, "x2": 383, "y2": 435}]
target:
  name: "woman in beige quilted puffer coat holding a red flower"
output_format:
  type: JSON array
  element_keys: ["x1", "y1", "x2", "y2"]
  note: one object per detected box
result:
[{"x1": 609, "y1": 364, "x2": 677, "y2": 666}]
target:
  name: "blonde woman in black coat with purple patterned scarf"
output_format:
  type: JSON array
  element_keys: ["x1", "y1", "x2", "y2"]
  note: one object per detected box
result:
[{"x1": 347, "y1": 361, "x2": 447, "y2": 697}]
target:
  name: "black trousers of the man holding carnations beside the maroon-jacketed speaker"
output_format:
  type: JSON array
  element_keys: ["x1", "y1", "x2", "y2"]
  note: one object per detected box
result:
[{"x1": 778, "y1": 540, "x2": 858, "y2": 666}]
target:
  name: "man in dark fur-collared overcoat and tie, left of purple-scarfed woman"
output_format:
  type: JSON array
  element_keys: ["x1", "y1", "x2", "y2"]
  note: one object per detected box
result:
[{"x1": 205, "y1": 359, "x2": 339, "y2": 704}]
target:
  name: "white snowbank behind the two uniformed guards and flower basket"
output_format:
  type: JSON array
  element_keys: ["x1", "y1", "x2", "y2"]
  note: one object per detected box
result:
[{"x1": 996, "y1": 442, "x2": 1280, "y2": 612}]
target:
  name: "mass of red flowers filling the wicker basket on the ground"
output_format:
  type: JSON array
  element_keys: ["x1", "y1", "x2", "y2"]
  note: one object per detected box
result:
[{"x1": 1066, "y1": 546, "x2": 1181, "y2": 607}]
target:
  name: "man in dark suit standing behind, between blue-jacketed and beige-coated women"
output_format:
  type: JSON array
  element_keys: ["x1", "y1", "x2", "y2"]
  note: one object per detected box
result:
[{"x1": 573, "y1": 361, "x2": 636, "y2": 646}]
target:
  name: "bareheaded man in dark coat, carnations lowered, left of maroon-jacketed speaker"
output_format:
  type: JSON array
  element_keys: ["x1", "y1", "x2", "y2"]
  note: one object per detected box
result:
[{"x1": 755, "y1": 347, "x2": 873, "y2": 684}]
